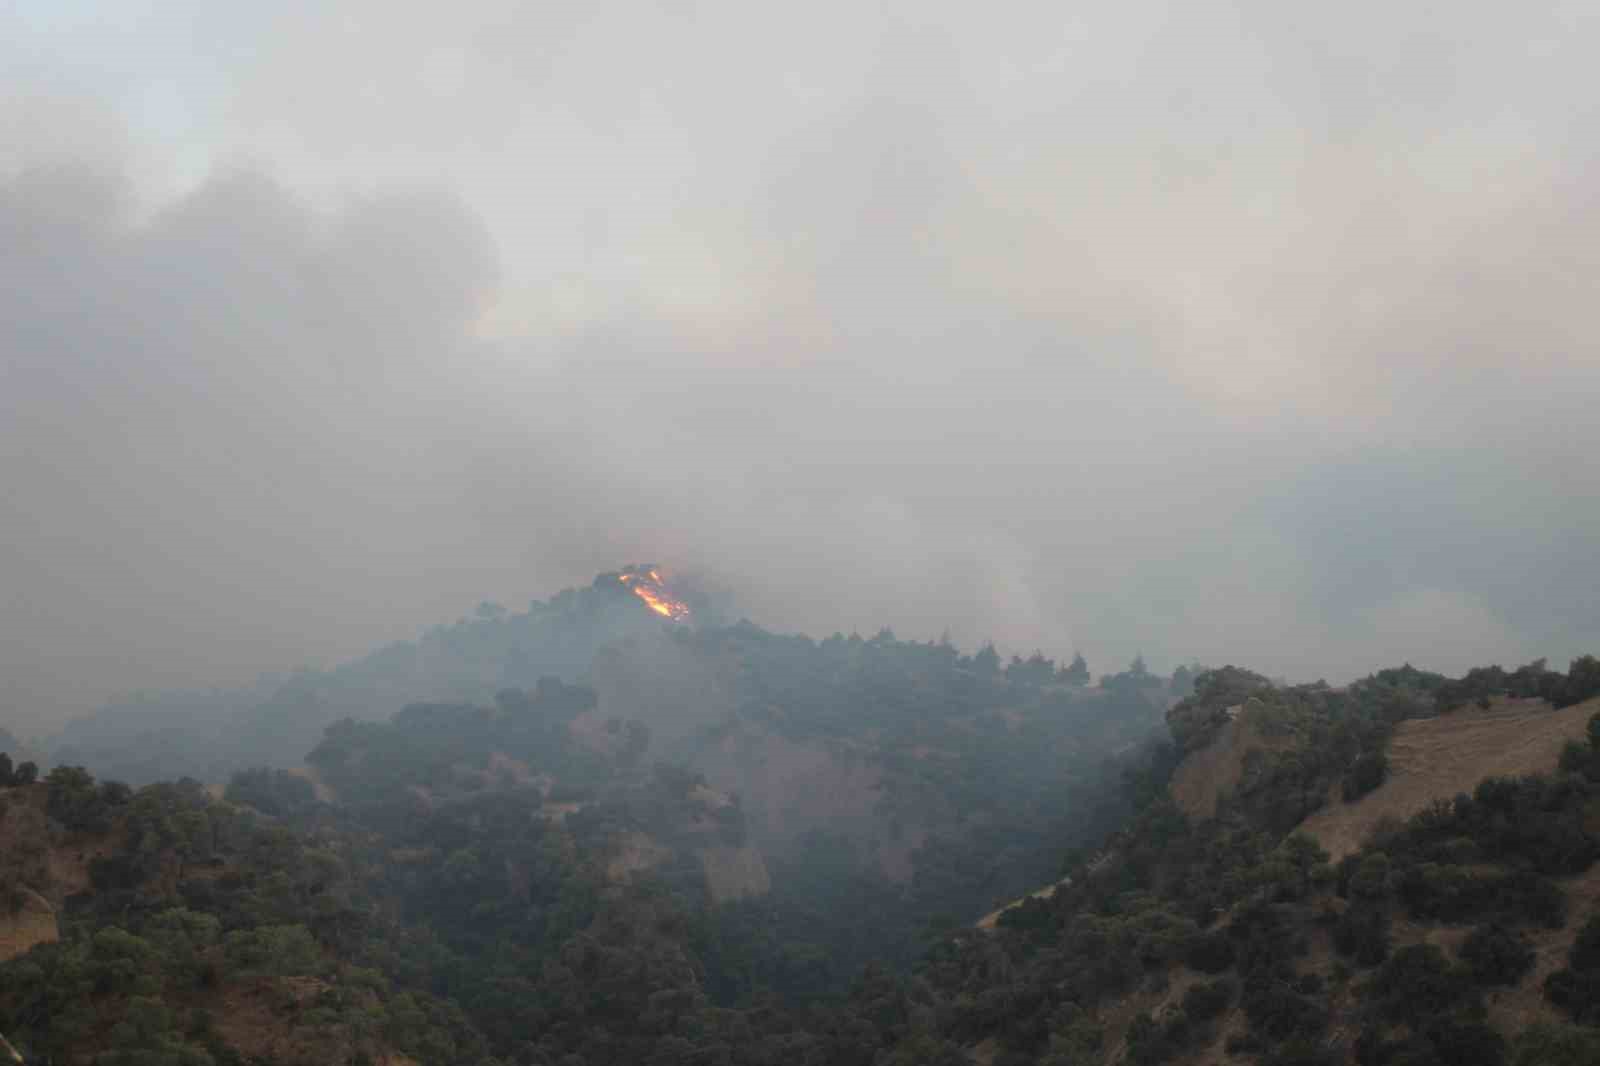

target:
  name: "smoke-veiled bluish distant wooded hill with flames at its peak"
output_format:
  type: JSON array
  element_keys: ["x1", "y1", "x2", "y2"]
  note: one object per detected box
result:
[{"x1": 43, "y1": 567, "x2": 1190, "y2": 921}]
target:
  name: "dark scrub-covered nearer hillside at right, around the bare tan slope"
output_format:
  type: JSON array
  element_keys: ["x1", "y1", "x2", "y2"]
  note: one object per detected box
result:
[{"x1": 922, "y1": 658, "x2": 1600, "y2": 1066}]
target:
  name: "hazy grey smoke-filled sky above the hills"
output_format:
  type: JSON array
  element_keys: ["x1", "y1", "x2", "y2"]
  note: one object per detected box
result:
[{"x1": 0, "y1": 0, "x2": 1600, "y2": 725}]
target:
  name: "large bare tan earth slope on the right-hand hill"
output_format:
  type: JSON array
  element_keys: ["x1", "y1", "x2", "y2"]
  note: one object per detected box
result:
[{"x1": 1305, "y1": 699, "x2": 1600, "y2": 861}]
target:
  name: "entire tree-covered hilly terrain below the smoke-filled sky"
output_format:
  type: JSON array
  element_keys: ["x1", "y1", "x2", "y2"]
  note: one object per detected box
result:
[{"x1": 9, "y1": 576, "x2": 1600, "y2": 1066}]
